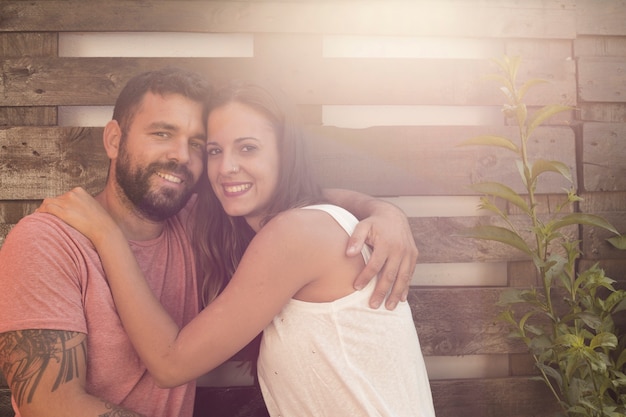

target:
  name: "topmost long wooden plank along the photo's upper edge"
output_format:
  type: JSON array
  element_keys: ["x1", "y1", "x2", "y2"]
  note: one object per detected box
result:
[{"x1": 0, "y1": 0, "x2": 576, "y2": 39}]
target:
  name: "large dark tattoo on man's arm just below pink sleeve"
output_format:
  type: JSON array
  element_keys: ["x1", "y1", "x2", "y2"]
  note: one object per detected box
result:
[{"x1": 0, "y1": 330, "x2": 87, "y2": 405}]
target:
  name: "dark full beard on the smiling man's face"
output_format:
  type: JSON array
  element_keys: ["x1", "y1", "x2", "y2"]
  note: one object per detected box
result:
[{"x1": 115, "y1": 146, "x2": 194, "y2": 221}]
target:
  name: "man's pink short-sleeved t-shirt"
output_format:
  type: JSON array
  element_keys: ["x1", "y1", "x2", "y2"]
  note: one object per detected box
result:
[{"x1": 0, "y1": 197, "x2": 199, "y2": 417}]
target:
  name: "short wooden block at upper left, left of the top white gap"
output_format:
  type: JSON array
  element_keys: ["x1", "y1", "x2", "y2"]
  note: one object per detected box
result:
[{"x1": 0, "y1": 32, "x2": 58, "y2": 58}]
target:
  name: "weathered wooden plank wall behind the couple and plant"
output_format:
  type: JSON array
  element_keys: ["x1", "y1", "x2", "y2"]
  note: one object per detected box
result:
[{"x1": 0, "y1": 0, "x2": 626, "y2": 417}]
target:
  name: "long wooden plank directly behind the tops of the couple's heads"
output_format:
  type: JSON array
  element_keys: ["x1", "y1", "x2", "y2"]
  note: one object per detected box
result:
[{"x1": 0, "y1": 56, "x2": 576, "y2": 106}]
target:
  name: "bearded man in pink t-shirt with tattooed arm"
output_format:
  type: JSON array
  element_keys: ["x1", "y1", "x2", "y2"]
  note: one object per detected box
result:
[{"x1": 0, "y1": 69, "x2": 417, "y2": 417}]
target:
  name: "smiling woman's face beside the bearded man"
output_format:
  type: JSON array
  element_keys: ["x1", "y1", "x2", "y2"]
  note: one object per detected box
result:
[{"x1": 207, "y1": 102, "x2": 279, "y2": 231}]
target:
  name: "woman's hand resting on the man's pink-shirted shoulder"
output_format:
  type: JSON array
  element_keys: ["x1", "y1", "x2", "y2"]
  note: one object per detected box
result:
[{"x1": 36, "y1": 187, "x2": 118, "y2": 246}]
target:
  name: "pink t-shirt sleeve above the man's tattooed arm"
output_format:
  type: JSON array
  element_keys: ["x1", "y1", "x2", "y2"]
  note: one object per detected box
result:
[{"x1": 0, "y1": 213, "x2": 91, "y2": 333}]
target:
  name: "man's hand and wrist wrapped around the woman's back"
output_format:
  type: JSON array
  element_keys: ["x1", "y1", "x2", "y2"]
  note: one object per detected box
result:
[{"x1": 324, "y1": 189, "x2": 418, "y2": 310}]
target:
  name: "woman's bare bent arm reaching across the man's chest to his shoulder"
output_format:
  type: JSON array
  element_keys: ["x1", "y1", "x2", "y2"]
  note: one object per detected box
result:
[{"x1": 39, "y1": 190, "x2": 332, "y2": 386}]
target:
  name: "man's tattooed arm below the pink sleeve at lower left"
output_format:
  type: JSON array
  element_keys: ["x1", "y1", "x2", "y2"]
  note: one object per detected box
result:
[{"x1": 0, "y1": 329, "x2": 140, "y2": 417}]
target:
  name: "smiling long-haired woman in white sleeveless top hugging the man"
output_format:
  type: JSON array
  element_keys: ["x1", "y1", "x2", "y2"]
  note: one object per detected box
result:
[{"x1": 37, "y1": 83, "x2": 434, "y2": 416}]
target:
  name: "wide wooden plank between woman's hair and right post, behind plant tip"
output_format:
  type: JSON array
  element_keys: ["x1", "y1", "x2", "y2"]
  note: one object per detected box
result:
[{"x1": 309, "y1": 126, "x2": 576, "y2": 196}]
